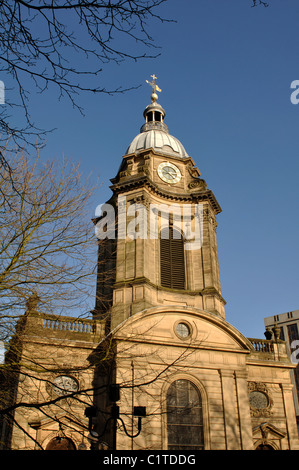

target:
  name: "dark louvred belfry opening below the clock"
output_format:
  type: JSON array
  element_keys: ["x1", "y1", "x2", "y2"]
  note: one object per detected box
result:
[{"x1": 160, "y1": 226, "x2": 185, "y2": 289}]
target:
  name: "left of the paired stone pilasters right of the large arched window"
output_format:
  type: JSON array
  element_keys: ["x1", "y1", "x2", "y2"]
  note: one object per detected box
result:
[{"x1": 219, "y1": 370, "x2": 240, "y2": 450}]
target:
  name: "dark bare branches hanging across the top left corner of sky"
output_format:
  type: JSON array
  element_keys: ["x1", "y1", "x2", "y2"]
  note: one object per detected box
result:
[{"x1": 0, "y1": 0, "x2": 168, "y2": 150}]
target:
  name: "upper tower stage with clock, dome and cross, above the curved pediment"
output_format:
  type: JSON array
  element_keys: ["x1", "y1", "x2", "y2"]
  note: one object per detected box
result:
[{"x1": 95, "y1": 75, "x2": 225, "y2": 329}]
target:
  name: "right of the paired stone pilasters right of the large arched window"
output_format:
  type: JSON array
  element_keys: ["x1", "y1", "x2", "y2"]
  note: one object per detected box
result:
[{"x1": 235, "y1": 370, "x2": 253, "y2": 450}]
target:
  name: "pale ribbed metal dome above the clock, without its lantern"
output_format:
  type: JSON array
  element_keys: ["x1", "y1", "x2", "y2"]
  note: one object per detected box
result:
[{"x1": 126, "y1": 129, "x2": 188, "y2": 158}]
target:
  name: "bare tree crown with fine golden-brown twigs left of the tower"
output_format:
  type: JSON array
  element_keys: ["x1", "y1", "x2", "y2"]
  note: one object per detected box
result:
[{"x1": 0, "y1": 152, "x2": 97, "y2": 336}]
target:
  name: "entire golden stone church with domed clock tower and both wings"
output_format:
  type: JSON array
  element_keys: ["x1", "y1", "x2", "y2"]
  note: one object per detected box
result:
[{"x1": 1, "y1": 81, "x2": 299, "y2": 451}]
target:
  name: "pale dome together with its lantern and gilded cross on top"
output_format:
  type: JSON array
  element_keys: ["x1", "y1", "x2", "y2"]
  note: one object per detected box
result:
[{"x1": 126, "y1": 75, "x2": 188, "y2": 158}]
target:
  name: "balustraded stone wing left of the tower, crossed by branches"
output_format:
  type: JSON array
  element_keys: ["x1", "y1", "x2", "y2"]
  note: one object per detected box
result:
[{"x1": 0, "y1": 312, "x2": 103, "y2": 450}]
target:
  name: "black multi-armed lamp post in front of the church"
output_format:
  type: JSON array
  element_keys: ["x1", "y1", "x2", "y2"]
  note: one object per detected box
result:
[{"x1": 85, "y1": 384, "x2": 146, "y2": 450}]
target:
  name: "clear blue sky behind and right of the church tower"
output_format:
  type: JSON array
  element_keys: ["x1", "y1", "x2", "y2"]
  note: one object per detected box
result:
[{"x1": 5, "y1": 0, "x2": 299, "y2": 338}]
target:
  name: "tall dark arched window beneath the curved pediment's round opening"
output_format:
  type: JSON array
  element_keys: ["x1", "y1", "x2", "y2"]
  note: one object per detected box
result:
[{"x1": 167, "y1": 380, "x2": 204, "y2": 450}]
